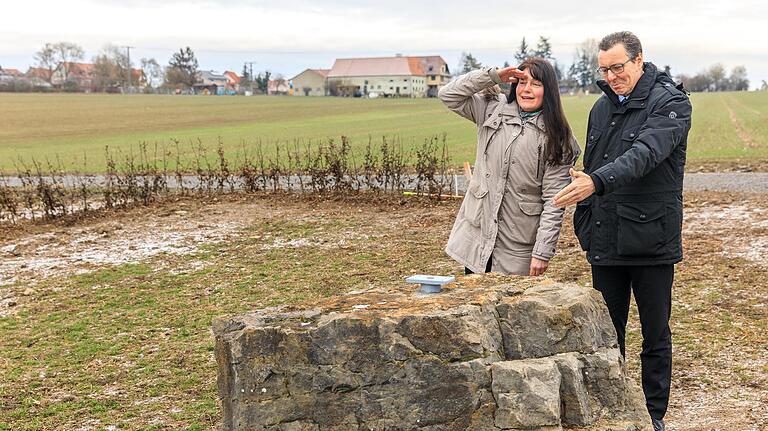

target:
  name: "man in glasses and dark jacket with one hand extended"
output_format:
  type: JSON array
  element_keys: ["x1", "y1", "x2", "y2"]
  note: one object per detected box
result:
[{"x1": 555, "y1": 31, "x2": 691, "y2": 430}]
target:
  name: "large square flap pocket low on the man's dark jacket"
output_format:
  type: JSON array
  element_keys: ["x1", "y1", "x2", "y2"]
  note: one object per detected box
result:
[{"x1": 616, "y1": 202, "x2": 668, "y2": 257}]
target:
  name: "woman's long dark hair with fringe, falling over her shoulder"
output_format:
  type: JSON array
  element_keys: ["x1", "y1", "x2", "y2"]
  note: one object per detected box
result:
[{"x1": 507, "y1": 57, "x2": 574, "y2": 166}]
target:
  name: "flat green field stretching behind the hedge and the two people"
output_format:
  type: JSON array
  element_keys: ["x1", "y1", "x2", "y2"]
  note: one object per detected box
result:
[{"x1": 0, "y1": 92, "x2": 768, "y2": 173}]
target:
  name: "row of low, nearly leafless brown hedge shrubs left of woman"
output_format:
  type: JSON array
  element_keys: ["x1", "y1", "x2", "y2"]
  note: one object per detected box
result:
[{"x1": 0, "y1": 134, "x2": 451, "y2": 223}]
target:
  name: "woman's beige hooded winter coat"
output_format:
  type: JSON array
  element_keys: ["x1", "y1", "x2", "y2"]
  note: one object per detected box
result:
[{"x1": 439, "y1": 68, "x2": 579, "y2": 275}]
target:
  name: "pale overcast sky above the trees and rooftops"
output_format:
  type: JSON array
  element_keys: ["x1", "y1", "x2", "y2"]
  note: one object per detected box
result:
[{"x1": 0, "y1": 0, "x2": 768, "y2": 88}]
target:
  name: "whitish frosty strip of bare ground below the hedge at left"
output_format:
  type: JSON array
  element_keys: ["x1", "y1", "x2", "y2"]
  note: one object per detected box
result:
[{"x1": 0, "y1": 202, "x2": 245, "y2": 287}]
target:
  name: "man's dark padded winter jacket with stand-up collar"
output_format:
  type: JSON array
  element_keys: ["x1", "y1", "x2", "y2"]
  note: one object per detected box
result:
[{"x1": 574, "y1": 63, "x2": 691, "y2": 265}]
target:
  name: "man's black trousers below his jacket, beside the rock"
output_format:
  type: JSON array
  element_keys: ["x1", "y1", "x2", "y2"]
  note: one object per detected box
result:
[{"x1": 592, "y1": 265, "x2": 675, "y2": 419}]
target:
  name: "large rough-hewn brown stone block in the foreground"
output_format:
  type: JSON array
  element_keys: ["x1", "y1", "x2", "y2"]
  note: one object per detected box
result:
[{"x1": 213, "y1": 276, "x2": 652, "y2": 431}]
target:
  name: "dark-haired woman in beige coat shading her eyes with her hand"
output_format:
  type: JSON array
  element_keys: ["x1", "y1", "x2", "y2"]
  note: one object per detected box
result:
[{"x1": 439, "y1": 58, "x2": 579, "y2": 276}]
